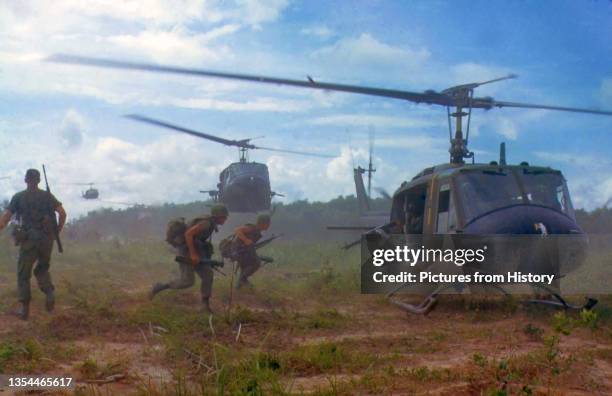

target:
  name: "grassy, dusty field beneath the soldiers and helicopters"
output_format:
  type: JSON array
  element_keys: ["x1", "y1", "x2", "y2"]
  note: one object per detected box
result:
[{"x1": 0, "y1": 234, "x2": 612, "y2": 395}]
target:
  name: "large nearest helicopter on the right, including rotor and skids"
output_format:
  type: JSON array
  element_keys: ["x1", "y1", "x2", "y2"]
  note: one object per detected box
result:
[{"x1": 49, "y1": 55, "x2": 612, "y2": 314}]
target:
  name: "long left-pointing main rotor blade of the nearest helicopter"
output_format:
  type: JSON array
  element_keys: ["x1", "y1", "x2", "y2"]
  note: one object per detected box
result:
[{"x1": 47, "y1": 54, "x2": 444, "y2": 106}]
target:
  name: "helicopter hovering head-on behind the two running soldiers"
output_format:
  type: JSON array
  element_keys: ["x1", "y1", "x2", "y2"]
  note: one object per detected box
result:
[{"x1": 126, "y1": 114, "x2": 333, "y2": 212}]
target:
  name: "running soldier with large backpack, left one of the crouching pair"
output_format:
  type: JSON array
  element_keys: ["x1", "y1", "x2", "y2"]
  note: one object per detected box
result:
[{"x1": 149, "y1": 204, "x2": 228, "y2": 313}]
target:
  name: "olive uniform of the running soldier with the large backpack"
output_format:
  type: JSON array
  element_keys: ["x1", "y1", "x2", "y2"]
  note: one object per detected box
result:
[{"x1": 153, "y1": 216, "x2": 217, "y2": 301}]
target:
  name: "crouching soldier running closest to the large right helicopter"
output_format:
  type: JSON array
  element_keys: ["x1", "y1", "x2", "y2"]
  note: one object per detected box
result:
[{"x1": 232, "y1": 214, "x2": 271, "y2": 288}]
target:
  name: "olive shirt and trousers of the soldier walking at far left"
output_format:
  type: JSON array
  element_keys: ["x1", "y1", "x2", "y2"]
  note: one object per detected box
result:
[{"x1": 8, "y1": 189, "x2": 61, "y2": 304}]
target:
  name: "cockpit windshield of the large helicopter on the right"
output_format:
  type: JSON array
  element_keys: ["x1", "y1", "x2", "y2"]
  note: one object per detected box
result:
[{"x1": 457, "y1": 169, "x2": 573, "y2": 222}]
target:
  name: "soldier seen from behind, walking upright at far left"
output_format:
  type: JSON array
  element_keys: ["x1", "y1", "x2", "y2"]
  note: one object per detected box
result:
[{"x1": 0, "y1": 169, "x2": 66, "y2": 320}]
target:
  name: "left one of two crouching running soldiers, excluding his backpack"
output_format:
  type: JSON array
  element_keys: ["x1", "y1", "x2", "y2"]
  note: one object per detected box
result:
[{"x1": 150, "y1": 204, "x2": 228, "y2": 314}]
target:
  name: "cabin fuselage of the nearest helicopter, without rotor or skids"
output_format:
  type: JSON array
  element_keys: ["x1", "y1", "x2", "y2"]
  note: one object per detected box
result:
[{"x1": 389, "y1": 163, "x2": 588, "y2": 273}]
